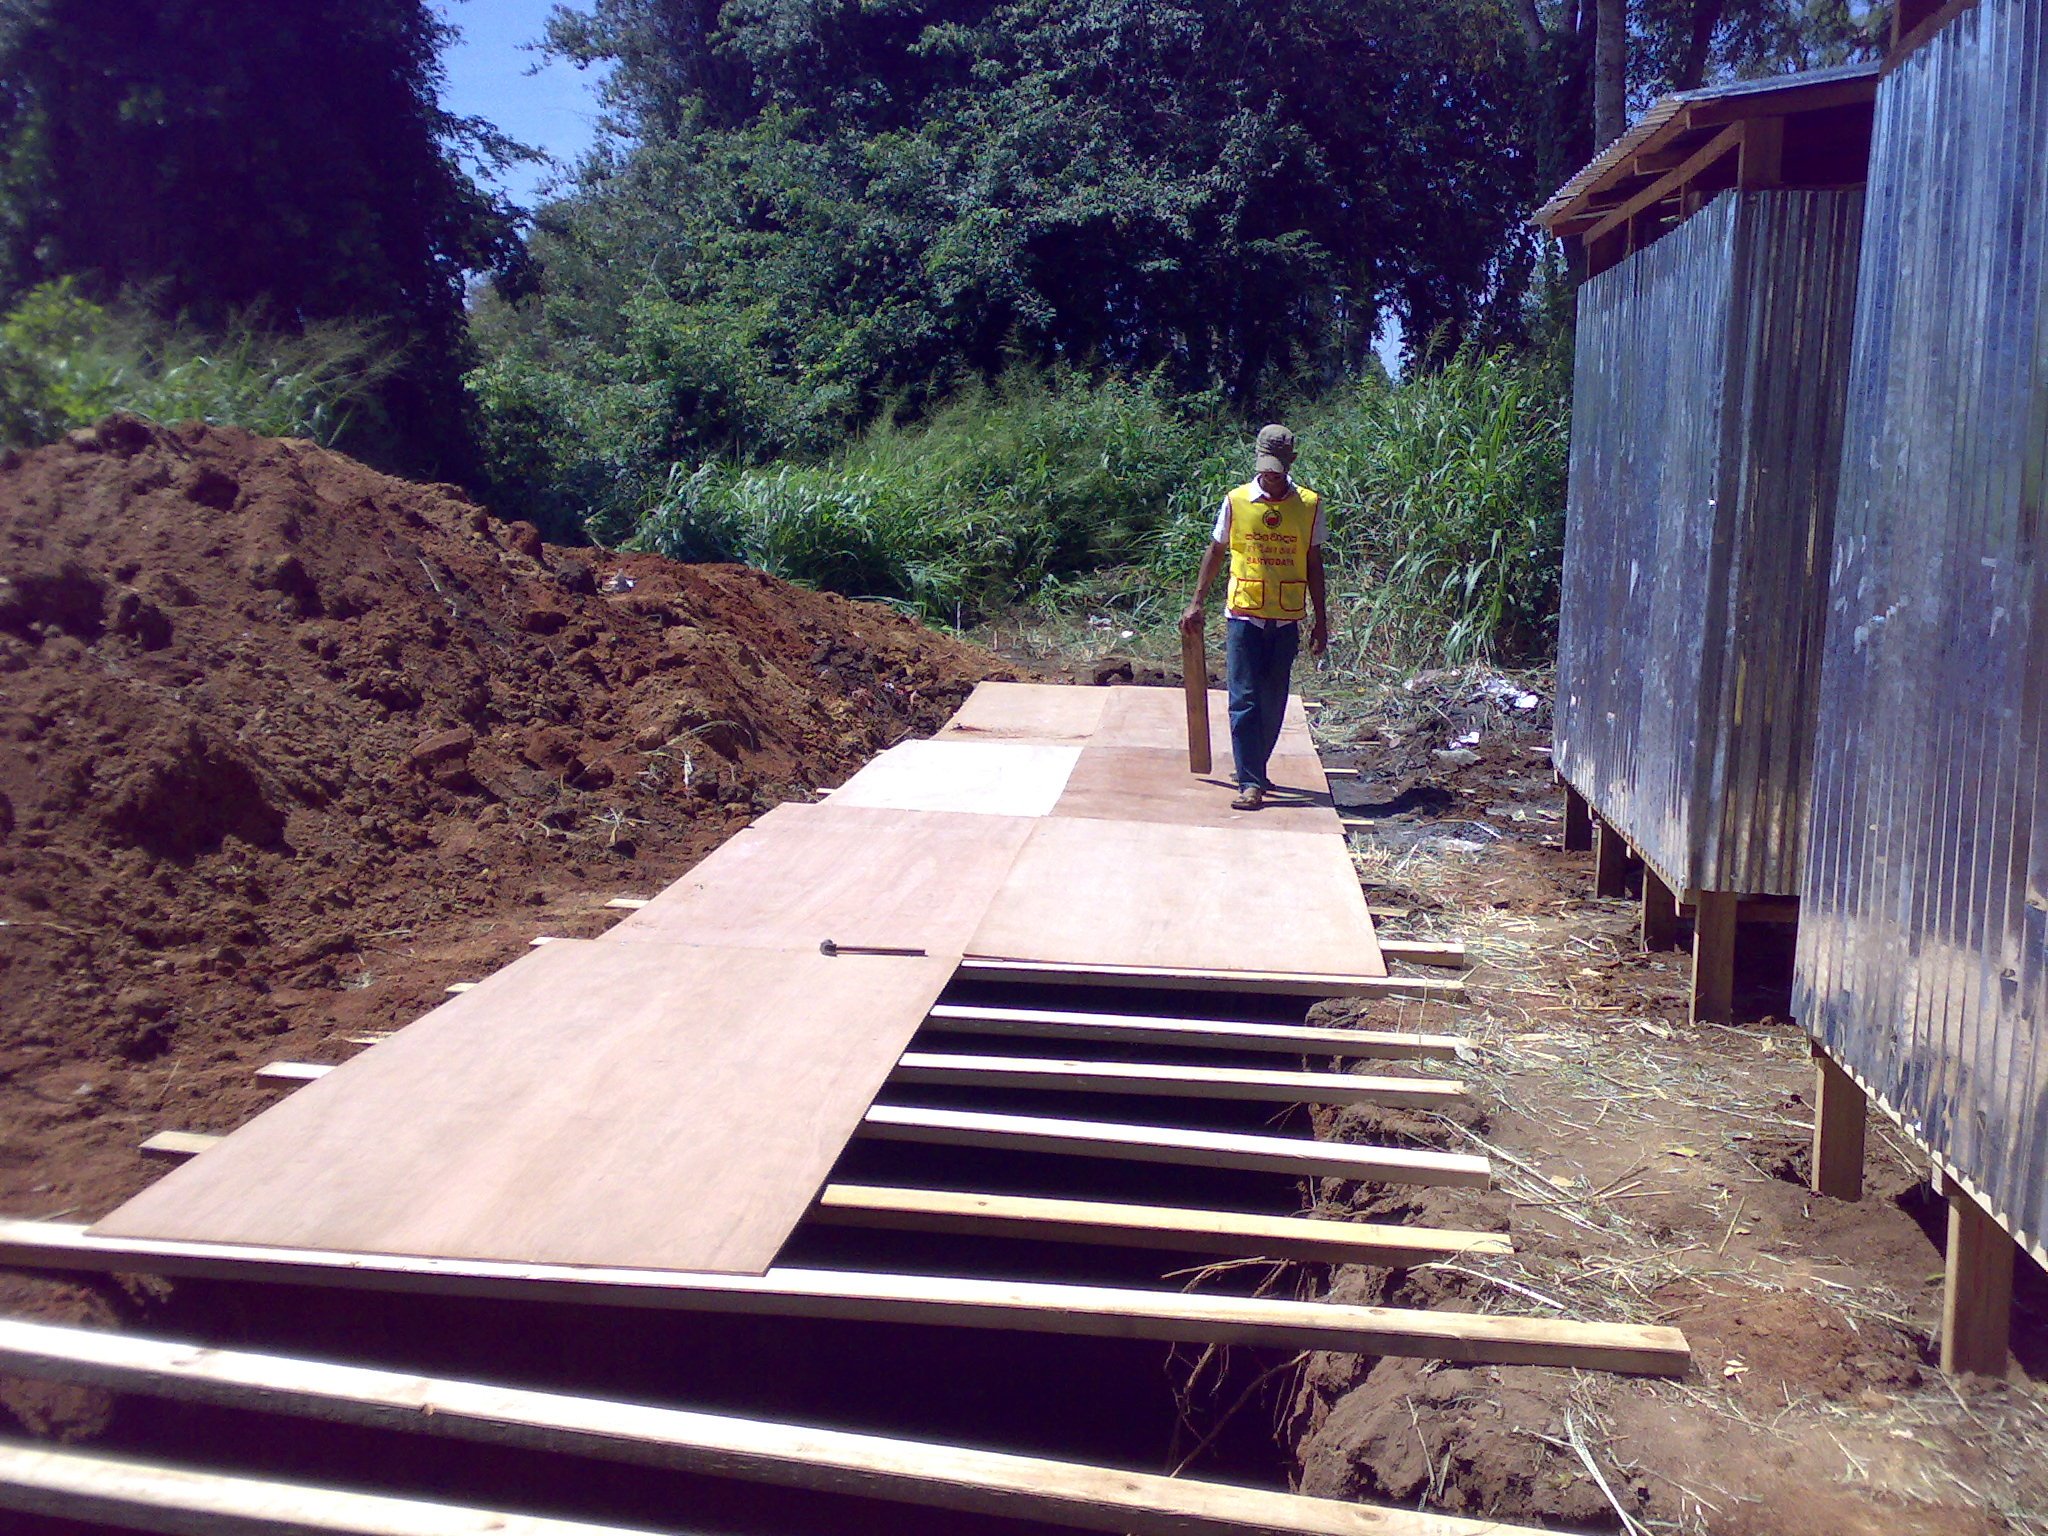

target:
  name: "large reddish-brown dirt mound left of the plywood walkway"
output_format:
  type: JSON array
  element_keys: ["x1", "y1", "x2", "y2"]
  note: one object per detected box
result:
[{"x1": 0, "y1": 418, "x2": 999, "y2": 1214}]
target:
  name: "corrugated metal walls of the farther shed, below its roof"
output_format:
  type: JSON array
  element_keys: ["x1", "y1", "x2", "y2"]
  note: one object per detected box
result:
[{"x1": 1556, "y1": 190, "x2": 1862, "y2": 895}]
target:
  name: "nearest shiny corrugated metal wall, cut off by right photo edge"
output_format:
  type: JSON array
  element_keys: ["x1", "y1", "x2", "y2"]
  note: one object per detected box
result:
[{"x1": 1794, "y1": 0, "x2": 2048, "y2": 1247}]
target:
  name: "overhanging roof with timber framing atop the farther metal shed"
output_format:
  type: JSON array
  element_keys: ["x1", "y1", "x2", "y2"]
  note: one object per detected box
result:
[{"x1": 1530, "y1": 63, "x2": 1880, "y2": 276}]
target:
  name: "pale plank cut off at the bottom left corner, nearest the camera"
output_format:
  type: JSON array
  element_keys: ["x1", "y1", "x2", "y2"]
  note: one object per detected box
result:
[{"x1": 0, "y1": 1442, "x2": 663, "y2": 1536}]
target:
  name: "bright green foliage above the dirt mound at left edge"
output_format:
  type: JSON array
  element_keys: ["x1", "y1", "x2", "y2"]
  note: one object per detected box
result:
[{"x1": 0, "y1": 279, "x2": 395, "y2": 446}]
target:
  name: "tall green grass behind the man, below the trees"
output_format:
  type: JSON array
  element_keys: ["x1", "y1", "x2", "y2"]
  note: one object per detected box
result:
[{"x1": 635, "y1": 354, "x2": 1569, "y2": 666}]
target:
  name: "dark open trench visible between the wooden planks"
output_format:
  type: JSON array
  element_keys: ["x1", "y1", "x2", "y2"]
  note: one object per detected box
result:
[{"x1": 23, "y1": 987, "x2": 1359, "y2": 1536}]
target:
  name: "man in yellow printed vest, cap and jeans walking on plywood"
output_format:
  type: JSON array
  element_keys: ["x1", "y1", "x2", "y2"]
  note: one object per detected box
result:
[{"x1": 1180, "y1": 426, "x2": 1329, "y2": 811}]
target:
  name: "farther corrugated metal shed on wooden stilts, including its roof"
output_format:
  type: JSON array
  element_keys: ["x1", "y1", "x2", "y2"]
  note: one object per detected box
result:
[{"x1": 1538, "y1": 66, "x2": 1876, "y2": 1018}]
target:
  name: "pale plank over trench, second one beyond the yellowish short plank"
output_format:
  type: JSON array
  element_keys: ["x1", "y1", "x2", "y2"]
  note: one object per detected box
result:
[{"x1": 889, "y1": 1051, "x2": 1464, "y2": 1108}]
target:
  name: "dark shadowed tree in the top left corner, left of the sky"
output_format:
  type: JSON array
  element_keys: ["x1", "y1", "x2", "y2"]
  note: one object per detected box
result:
[{"x1": 0, "y1": 0, "x2": 516, "y2": 473}]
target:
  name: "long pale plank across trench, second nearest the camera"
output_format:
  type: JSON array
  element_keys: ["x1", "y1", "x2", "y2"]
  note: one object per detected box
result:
[{"x1": 0, "y1": 1323, "x2": 1548, "y2": 1536}]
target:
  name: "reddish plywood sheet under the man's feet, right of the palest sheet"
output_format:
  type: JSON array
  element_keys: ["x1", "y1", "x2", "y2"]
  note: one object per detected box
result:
[{"x1": 1053, "y1": 748, "x2": 1343, "y2": 836}]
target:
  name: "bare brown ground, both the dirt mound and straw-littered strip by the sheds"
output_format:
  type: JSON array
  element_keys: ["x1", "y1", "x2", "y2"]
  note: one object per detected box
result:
[{"x1": 0, "y1": 422, "x2": 2048, "y2": 1536}]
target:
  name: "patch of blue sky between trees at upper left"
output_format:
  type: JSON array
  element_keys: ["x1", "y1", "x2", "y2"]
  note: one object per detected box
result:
[{"x1": 430, "y1": 0, "x2": 614, "y2": 207}]
